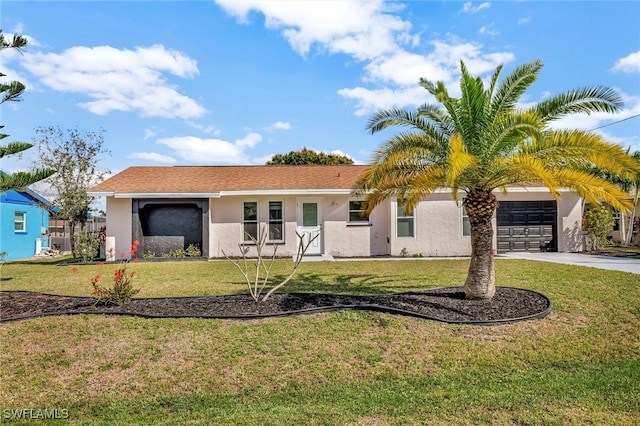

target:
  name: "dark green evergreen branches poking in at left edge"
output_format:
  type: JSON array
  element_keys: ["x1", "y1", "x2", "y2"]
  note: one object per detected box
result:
[{"x1": 0, "y1": 29, "x2": 55, "y2": 192}]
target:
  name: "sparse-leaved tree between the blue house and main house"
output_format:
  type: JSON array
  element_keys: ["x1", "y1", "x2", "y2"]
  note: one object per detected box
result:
[{"x1": 36, "y1": 126, "x2": 109, "y2": 240}]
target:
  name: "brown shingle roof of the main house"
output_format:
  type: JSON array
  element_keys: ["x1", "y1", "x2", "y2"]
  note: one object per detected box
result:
[{"x1": 90, "y1": 165, "x2": 367, "y2": 194}]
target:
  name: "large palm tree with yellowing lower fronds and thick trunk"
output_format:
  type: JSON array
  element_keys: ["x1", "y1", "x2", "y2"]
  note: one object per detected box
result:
[{"x1": 358, "y1": 61, "x2": 638, "y2": 299}]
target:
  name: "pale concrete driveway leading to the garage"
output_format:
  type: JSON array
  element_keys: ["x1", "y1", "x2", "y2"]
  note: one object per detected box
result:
[{"x1": 497, "y1": 252, "x2": 640, "y2": 274}]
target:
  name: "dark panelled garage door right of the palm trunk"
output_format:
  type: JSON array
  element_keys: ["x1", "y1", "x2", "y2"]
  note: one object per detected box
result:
[{"x1": 497, "y1": 201, "x2": 558, "y2": 252}]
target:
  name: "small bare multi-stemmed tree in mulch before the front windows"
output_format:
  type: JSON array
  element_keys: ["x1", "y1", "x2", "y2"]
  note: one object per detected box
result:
[{"x1": 222, "y1": 228, "x2": 319, "y2": 303}]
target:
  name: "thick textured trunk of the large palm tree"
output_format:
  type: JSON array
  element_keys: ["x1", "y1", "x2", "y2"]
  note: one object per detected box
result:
[{"x1": 464, "y1": 190, "x2": 498, "y2": 299}]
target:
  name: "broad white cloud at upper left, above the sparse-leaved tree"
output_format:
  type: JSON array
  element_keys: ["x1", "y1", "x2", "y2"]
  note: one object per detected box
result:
[{"x1": 23, "y1": 45, "x2": 206, "y2": 118}]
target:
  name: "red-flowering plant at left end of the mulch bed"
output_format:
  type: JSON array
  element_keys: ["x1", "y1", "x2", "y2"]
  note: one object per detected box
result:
[{"x1": 91, "y1": 240, "x2": 140, "y2": 306}]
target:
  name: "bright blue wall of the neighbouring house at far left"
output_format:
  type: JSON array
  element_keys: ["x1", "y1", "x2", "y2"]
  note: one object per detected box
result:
[{"x1": 0, "y1": 191, "x2": 49, "y2": 260}]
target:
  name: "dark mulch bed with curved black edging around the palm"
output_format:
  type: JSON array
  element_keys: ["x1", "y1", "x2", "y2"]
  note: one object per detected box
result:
[{"x1": 0, "y1": 287, "x2": 551, "y2": 325}]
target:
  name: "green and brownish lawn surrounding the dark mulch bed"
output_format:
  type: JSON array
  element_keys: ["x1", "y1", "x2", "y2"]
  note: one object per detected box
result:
[{"x1": 0, "y1": 259, "x2": 640, "y2": 425}]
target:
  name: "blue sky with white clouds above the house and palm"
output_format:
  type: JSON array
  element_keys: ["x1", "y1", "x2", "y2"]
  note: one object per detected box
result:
[{"x1": 0, "y1": 0, "x2": 640, "y2": 178}]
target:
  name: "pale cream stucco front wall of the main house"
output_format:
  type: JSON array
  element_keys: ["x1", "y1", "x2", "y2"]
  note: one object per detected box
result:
[{"x1": 107, "y1": 190, "x2": 583, "y2": 258}]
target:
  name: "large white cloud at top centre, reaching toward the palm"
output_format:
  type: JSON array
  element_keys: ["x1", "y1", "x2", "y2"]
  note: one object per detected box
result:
[{"x1": 216, "y1": 0, "x2": 514, "y2": 115}]
